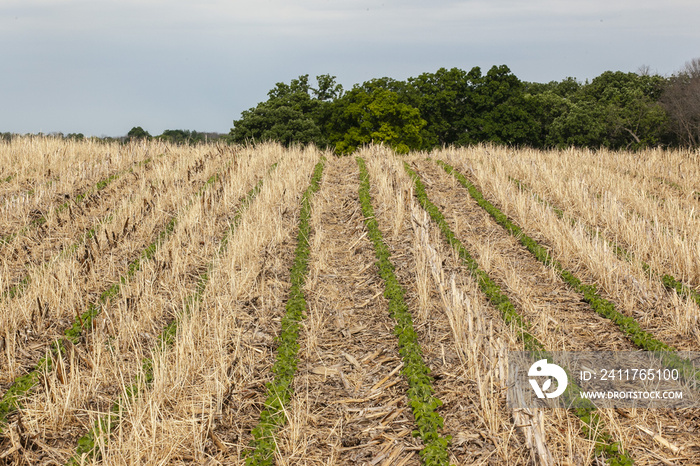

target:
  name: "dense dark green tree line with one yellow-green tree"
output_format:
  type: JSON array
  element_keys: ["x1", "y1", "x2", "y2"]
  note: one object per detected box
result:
[{"x1": 228, "y1": 59, "x2": 700, "y2": 153}]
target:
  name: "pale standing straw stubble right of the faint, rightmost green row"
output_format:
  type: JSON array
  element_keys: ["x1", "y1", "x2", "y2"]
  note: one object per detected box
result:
[{"x1": 455, "y1": 148, "x2": 700, "y2": 289}]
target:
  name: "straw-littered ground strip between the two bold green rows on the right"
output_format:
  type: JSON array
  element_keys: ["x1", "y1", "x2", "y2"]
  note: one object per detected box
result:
[{"x1": 414, "y1": 160, "x2": 700, "y2": 464}]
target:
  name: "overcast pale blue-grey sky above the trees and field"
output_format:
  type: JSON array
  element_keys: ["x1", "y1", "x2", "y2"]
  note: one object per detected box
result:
[{"x1": 0, "y1": 0, "x2": 700, "y2": 136}]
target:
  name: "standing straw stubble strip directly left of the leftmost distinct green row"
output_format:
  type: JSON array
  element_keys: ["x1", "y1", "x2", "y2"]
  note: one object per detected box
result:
[{"x1": 0, "y1": 143, "x2": 220, "y2": 388}]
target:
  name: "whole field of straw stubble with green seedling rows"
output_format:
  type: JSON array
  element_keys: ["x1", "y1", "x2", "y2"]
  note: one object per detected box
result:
[{"x1": 0, "y1": 138, "x2": 700, "y2": 466}]
